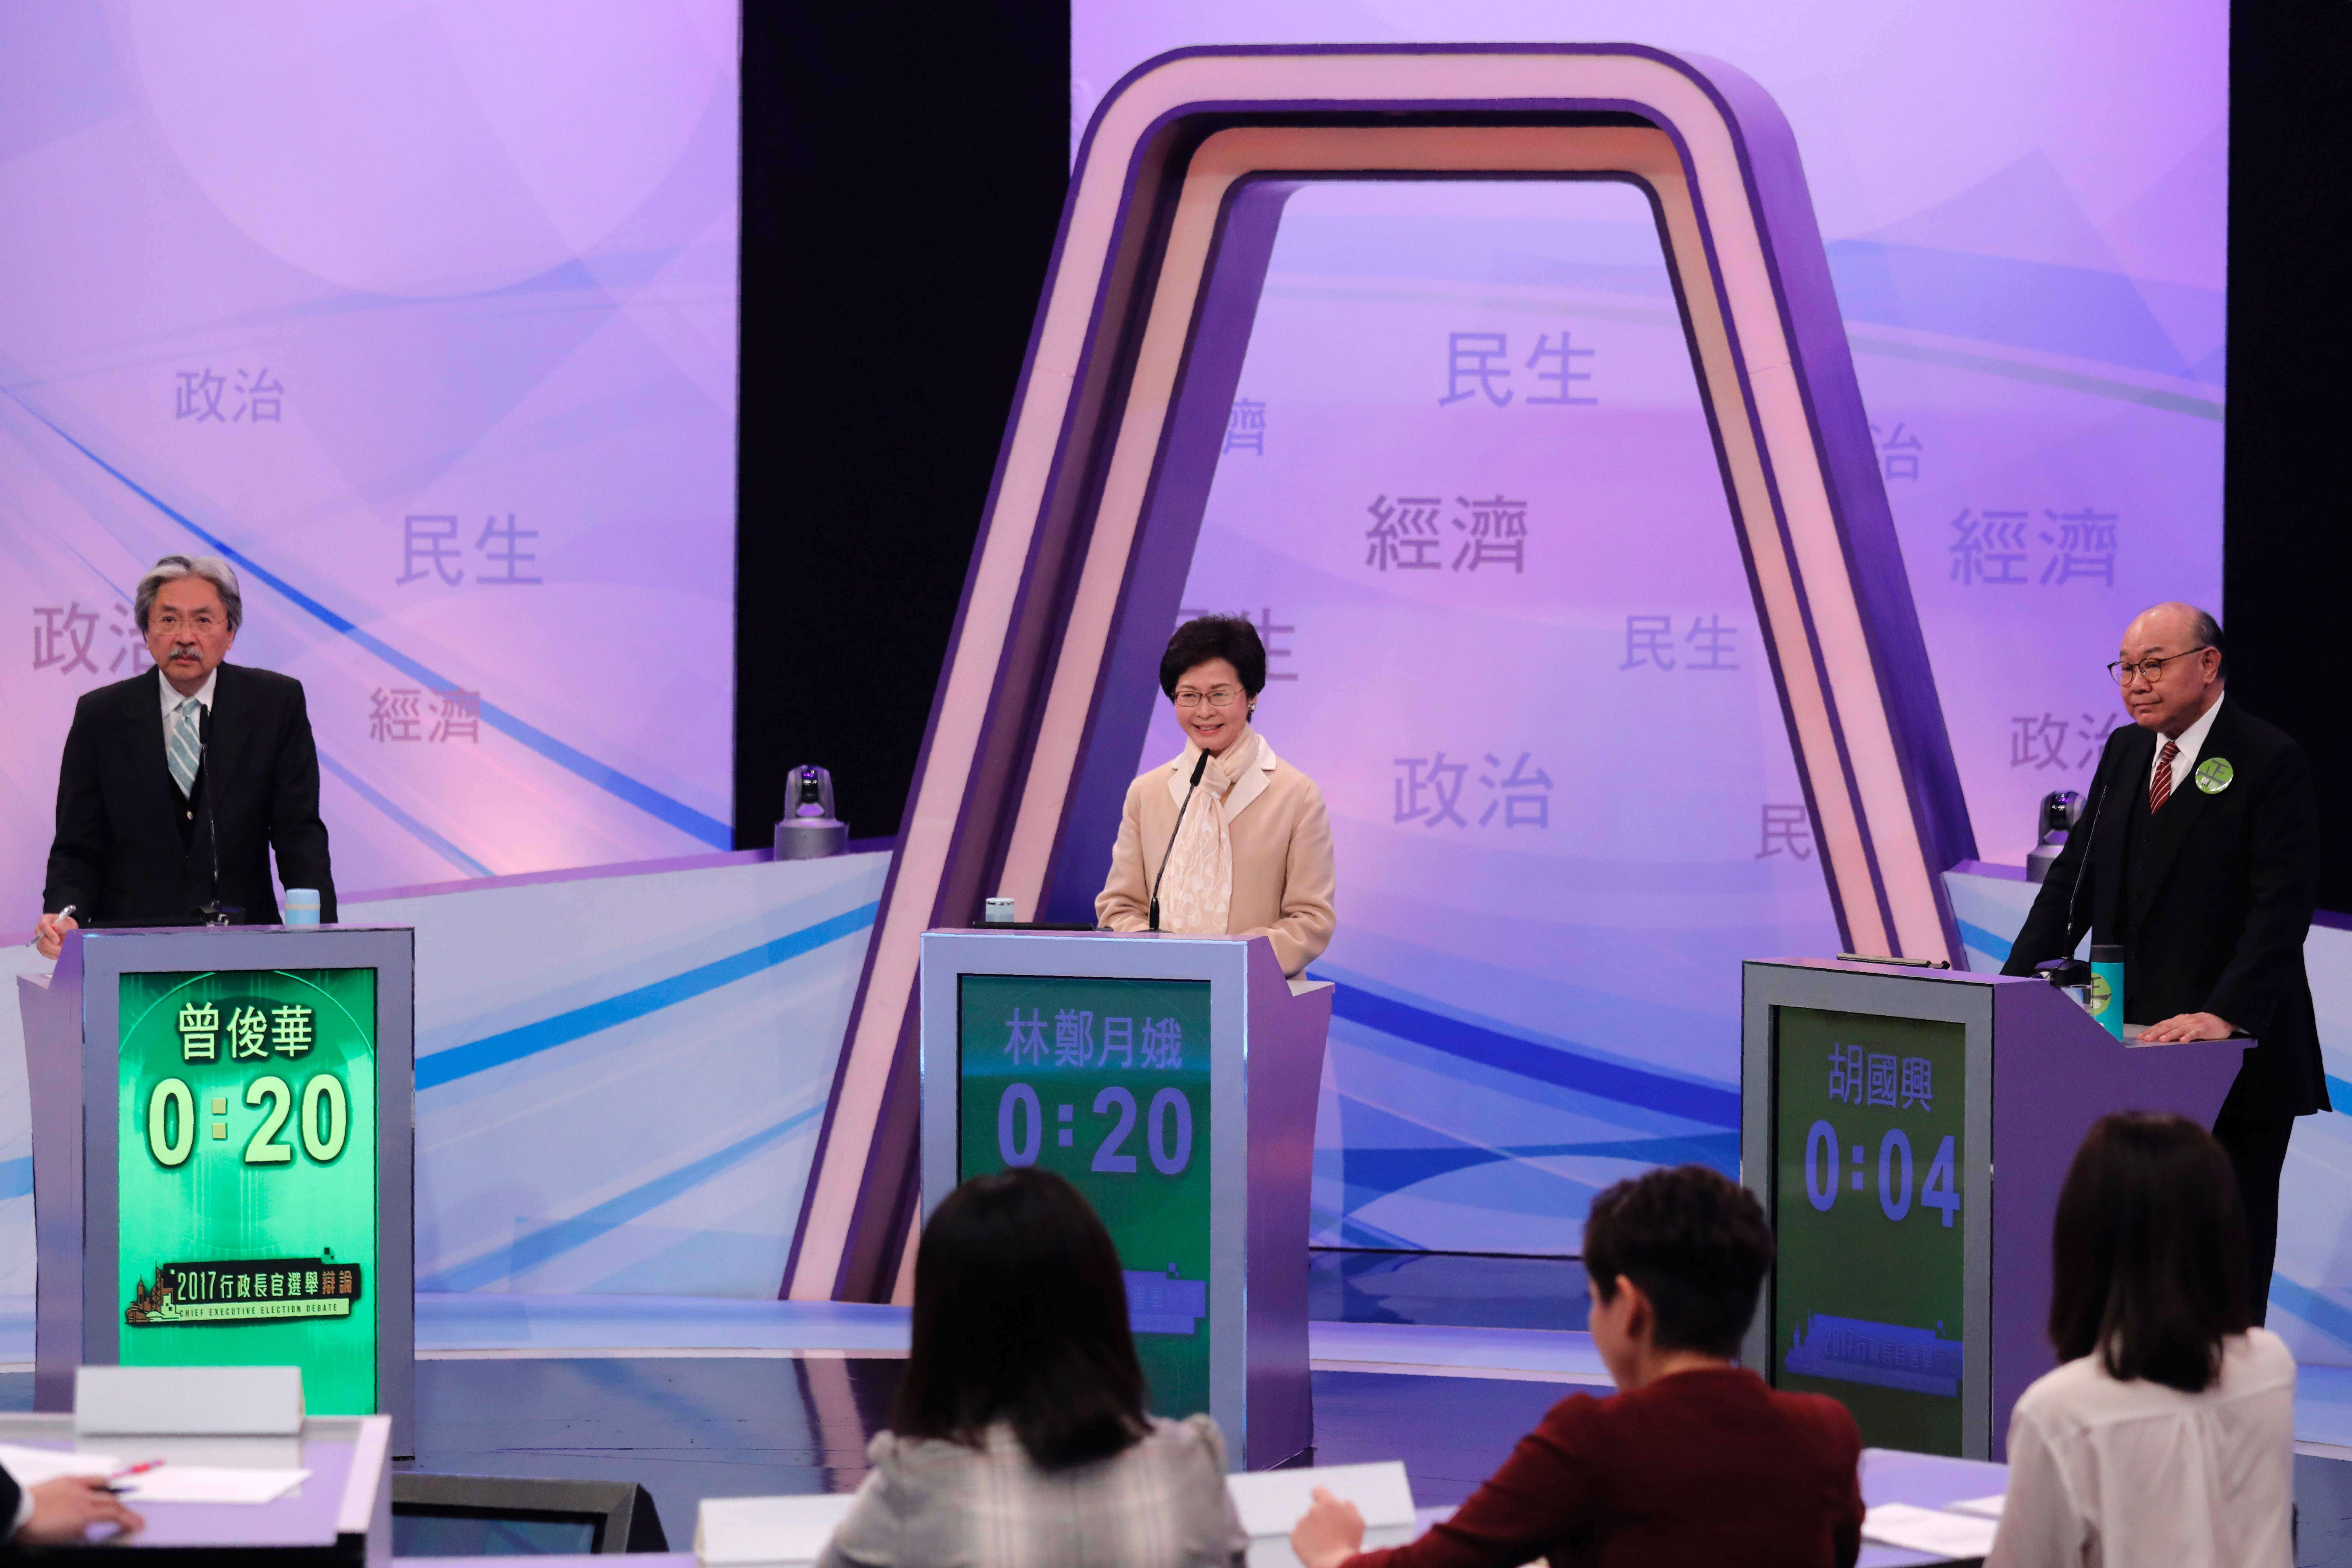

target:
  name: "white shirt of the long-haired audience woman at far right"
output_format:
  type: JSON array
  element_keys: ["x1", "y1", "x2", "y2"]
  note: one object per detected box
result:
[{"x1": 1985, "y1": 1328, "x2": 2296, "y2": 1568}]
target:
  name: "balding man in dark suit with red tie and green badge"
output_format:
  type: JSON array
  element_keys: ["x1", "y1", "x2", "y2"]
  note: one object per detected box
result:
[{"x1": 2001, "y1": 604, "x2": 2331, "y2": 1321}]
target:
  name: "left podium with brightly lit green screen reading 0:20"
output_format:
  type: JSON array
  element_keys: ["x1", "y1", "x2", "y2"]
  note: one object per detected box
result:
[{"x1": 17, "y1": 926, "x2": 416, "y2": 1455}]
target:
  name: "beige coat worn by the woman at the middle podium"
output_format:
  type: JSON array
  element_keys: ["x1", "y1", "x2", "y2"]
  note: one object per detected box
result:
[{"x1": 1094, "y1": 736, "x2": 1333, "y2": 975}]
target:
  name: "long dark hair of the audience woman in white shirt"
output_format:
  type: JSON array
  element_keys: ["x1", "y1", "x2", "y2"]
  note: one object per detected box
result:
[{"x1": 2051, "y1": 1110, "x2": 2251, "y2": 1394}]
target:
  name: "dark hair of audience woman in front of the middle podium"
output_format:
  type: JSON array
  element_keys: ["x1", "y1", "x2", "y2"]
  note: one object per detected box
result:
[{"x1": 892, "y1": 1166, "x2": 1150, "y2": 1469}]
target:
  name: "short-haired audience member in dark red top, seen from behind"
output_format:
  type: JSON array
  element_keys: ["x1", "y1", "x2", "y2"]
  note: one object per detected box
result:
[{"x1": 1291, "y1": 1166, "x2": 1863, "y2": 1568}]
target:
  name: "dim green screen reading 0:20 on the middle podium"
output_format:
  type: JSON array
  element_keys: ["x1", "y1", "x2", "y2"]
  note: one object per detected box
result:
[{"x1": 955, "y1": 975, "x2": 1211, "y2": 1415}]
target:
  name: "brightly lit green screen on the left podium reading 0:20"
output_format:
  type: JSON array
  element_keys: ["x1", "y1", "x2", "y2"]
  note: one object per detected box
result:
[{"x1": 115, "y1": 968, "x2": 376, "y2": 1415}]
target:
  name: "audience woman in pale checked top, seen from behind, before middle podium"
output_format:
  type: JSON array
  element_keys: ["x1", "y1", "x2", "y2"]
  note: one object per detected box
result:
[{"x1": 819, "y1": 1168, "x2": 1249, "y2": 1568}]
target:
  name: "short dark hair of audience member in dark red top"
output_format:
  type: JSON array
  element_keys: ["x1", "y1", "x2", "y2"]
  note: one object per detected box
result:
[{"x1": 1585, "y1": 1166, "x2": 1773, "y2": 1356}]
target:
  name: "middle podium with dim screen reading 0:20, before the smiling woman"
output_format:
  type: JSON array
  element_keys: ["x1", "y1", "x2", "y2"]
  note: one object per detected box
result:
[{"x1": 922, "y1": 929, "x2": 1331, "y2": 1469}]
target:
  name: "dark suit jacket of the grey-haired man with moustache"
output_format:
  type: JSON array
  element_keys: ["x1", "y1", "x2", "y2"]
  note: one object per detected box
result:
[{"x1": 40, "y1": 663, "x2": 334, "y2": 926}]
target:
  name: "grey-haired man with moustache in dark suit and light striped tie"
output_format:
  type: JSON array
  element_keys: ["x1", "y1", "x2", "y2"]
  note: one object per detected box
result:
[{"x1": 35, "y1": 555, "x2": 334, "y2": 957}]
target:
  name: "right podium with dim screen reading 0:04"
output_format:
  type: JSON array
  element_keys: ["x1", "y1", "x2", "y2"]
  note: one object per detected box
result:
[{"x1": 1740, "y1": 959, "x2": 2253, "y2": 1460}]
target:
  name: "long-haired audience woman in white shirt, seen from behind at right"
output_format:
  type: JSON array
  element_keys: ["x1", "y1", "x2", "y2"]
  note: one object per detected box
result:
[{"x1": 1985, "y1": 1112, "x2": 2296, "y2": 1568}]
